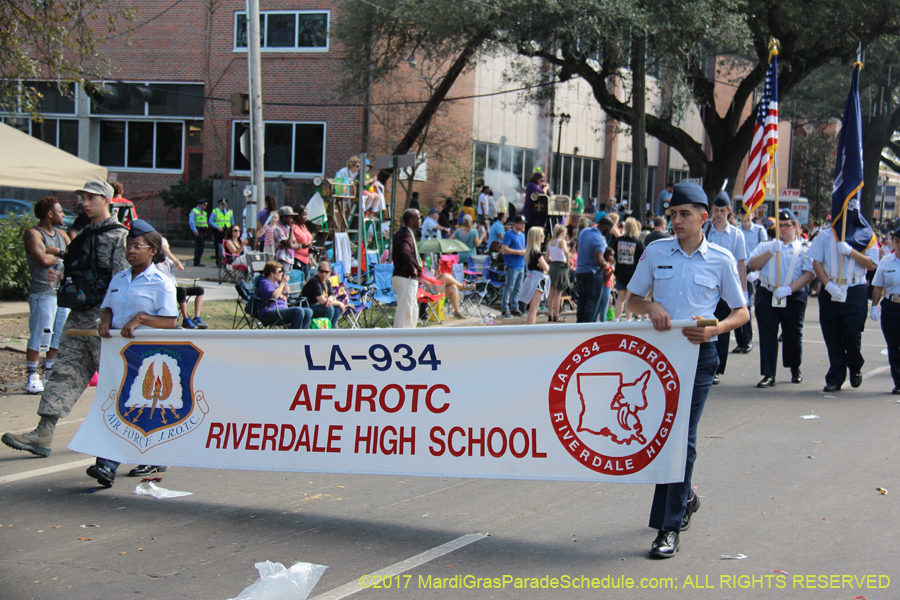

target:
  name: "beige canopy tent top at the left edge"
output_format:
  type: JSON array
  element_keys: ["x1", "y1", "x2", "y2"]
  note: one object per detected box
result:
[{"x1": 0, "y1": 123, "x2": 107, "y2": 191}]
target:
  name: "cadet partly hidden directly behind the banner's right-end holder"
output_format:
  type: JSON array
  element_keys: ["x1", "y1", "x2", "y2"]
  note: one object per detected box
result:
[{"x1": 705, "y1": 192, "x2": 753, "y2": 384}]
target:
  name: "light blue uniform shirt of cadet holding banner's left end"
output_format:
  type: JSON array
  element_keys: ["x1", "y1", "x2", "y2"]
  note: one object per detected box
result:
[{"x1": 100, "y1": 263, "x2": 178, "y2": 329}]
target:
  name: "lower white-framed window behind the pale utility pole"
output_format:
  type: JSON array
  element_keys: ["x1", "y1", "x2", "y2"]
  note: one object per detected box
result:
[{"x1": 231, "y1": 121, "x2": 325, "y2": 177}]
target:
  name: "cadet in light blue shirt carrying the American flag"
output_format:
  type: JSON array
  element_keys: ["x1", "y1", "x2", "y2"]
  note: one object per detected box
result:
[{"x1": 748, "y1": 210, "x2": 815, "y2": 388}]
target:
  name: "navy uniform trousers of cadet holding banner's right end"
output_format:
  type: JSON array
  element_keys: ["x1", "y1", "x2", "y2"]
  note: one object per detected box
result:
[{"x1": 650, "y1": 342, "x2": 719, "y2": 531}]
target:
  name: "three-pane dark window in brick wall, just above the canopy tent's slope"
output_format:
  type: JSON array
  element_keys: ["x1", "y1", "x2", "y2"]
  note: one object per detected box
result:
[{"x1": 100, "y1": 119, "x2": 184, "y2": 172}]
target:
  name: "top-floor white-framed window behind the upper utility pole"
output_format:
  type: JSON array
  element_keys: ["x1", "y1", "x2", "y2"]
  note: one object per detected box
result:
[{"x1": 234, "y1": 10, "x2": 331, "y2": 52}]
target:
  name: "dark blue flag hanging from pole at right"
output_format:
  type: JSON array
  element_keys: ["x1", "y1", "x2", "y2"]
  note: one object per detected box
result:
[{"x1": 831, "y1": 63, "x2": 875, "y2": 252}]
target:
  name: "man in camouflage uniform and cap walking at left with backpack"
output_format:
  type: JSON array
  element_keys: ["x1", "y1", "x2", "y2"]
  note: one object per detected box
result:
[{"x1": 0, "y1": 181, "x2": 128, "y2": 456}]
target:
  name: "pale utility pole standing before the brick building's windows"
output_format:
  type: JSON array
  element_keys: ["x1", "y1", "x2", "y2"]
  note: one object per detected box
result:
[{"x1": 244, "y1": 0, "x2": 266, "y2": 227}]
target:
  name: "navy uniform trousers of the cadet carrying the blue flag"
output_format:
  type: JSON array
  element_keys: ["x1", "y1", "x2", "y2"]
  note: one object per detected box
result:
[{"x1": 819, "y1": 285, "x2": 869, "y2": 386}]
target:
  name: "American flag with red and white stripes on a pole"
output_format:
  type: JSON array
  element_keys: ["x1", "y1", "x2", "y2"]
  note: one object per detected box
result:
[{"x1": 744, "y1": 50, "x2": 778, "y2": 213}]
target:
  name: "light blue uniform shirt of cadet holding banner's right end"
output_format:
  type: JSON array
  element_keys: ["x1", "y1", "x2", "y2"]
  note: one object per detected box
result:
[{"x1": 628, "y1": 238, "x2": 745, "y2": 320}]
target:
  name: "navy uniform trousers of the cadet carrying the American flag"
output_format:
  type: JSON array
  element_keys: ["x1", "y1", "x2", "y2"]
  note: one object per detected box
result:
[{"x1": 755, "y1": 286, "x2": 807, "y2": 377}]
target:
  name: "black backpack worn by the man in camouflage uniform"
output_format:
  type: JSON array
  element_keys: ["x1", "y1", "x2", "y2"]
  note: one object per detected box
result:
[{"x1": 56, "y1": 223, "x2": 127, "y2": 310}]
